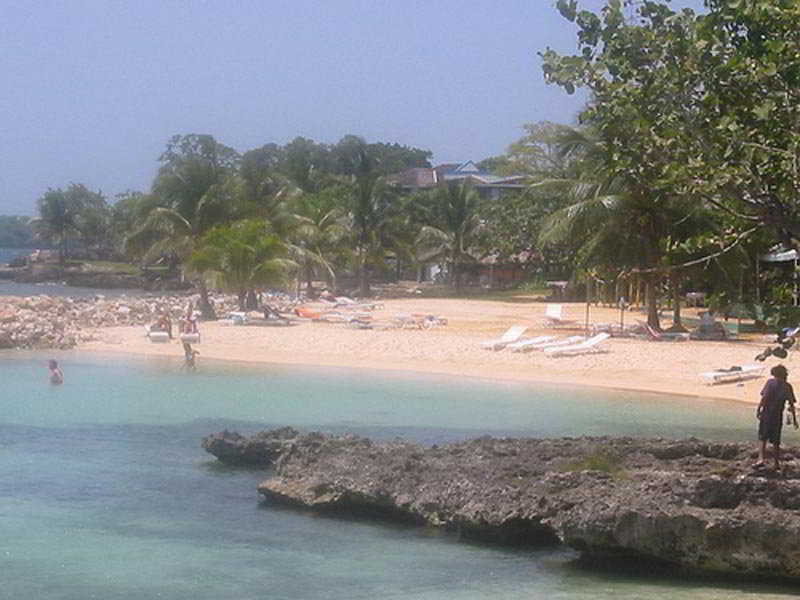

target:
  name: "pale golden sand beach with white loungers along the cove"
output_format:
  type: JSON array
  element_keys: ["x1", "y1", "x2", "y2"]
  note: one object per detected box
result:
[{"x1": 80, "y1": 298, "x2": 780, "y2": 403}]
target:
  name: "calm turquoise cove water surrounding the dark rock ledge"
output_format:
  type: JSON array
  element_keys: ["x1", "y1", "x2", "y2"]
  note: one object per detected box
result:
[{"x1": 0, "y1": 354, "x2": 797, "y2": 600}]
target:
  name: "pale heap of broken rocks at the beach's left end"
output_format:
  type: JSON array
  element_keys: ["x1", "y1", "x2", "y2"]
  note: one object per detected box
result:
[{"x1": 0, "y1": 296, "x2": 241, "y2": 349}]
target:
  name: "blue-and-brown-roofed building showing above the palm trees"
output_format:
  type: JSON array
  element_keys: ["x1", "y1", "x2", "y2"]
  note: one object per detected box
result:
[{"x1": 388, "y1": 160, "x2": 525, "y2": 199}]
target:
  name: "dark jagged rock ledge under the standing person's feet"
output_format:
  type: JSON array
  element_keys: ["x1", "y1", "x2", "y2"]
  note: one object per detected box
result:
[{"x1": 204, "y1": 429, "x2": 800, "y2": 578}]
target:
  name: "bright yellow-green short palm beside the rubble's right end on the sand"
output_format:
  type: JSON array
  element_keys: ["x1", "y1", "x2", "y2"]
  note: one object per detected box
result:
[{"x1": 187, "y1": 220, "x2": 296, "y2": 310}]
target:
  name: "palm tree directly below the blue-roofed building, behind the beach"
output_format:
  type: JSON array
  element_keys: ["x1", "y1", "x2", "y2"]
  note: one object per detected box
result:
[{"x1": 419, "y1": 181, "x2": 481, "y2": 291}]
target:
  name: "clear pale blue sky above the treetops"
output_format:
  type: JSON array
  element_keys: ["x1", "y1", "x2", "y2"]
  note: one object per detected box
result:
[{"x1": 0, "y1": 0, "x2": 702, "y2": 215}]
